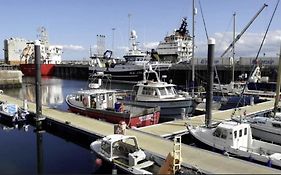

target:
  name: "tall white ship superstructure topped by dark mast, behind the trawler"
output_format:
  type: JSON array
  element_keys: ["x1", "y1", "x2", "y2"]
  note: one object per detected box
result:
[{"x1": 156, "y1": 18, "x2": 192, "y2": 62}]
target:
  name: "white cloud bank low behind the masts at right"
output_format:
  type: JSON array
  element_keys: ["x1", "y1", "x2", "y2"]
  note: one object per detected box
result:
[{"x1": 195, "y1": 30, "x2": 281, "y2": 57}]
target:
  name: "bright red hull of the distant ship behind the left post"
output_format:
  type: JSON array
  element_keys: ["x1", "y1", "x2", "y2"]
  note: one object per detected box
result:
[{"x1": 20, "y1": 64, "x2": 55, "y2": 77}]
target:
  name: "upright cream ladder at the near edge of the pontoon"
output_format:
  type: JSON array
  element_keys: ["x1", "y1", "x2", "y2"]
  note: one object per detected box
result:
[{"x1": 173, "y1": 135, "x2": 181, "y2": 173}]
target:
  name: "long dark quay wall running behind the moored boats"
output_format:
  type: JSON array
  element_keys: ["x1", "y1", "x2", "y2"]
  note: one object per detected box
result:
[{"x1": 54, "y1": 64, "x2": 277, "y2": 86}]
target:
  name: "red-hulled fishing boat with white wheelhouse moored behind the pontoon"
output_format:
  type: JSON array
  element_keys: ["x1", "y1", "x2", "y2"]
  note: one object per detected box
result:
[{"x1": 66, "y1": 73, "x2": 160, "y2": 127}]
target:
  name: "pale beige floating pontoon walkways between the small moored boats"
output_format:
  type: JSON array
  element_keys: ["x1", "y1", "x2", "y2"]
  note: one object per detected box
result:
[{"x1": 0, "y1": 94, "x2": 281, "y2": 174}]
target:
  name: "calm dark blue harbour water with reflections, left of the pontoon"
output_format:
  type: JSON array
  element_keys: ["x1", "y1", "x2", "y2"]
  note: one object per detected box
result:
[{"x1": 0, "y1": 77, "x2": 131, "y2": 174}]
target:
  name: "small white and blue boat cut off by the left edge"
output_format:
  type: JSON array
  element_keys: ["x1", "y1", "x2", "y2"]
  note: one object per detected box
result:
[{"x1": 0, "y1": 101, "x2": 29, "y2": 123}]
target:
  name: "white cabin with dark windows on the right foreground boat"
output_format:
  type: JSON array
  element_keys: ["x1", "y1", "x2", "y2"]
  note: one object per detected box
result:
[{"x1": 212, "y1": 122, "x2": 252, "y2": 150}]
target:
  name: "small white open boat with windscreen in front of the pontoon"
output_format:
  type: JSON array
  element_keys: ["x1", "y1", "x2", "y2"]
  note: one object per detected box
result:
[{"x1": 90, "y1": 134, "x2": 160, "y2": 174}]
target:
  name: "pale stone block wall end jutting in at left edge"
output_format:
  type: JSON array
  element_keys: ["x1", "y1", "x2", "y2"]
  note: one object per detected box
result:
[{"x1": 0, "y1": 70, "x2": 23, "y2": 88}]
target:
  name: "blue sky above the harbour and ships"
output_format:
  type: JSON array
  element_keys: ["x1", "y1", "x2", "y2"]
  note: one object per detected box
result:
[{"x1": 0, "y1": 0, "x2": 281, "y2": 60}]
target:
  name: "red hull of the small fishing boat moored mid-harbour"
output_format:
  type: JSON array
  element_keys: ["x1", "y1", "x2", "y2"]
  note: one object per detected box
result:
[{"x1": 69, "y1": 106, "x2": 160, "y2": 127}]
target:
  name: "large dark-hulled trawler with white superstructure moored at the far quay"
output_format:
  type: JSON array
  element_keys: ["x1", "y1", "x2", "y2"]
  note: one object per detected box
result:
[{"x1": 89, "y1": 30, "x2": 172, "y2": 83}]
